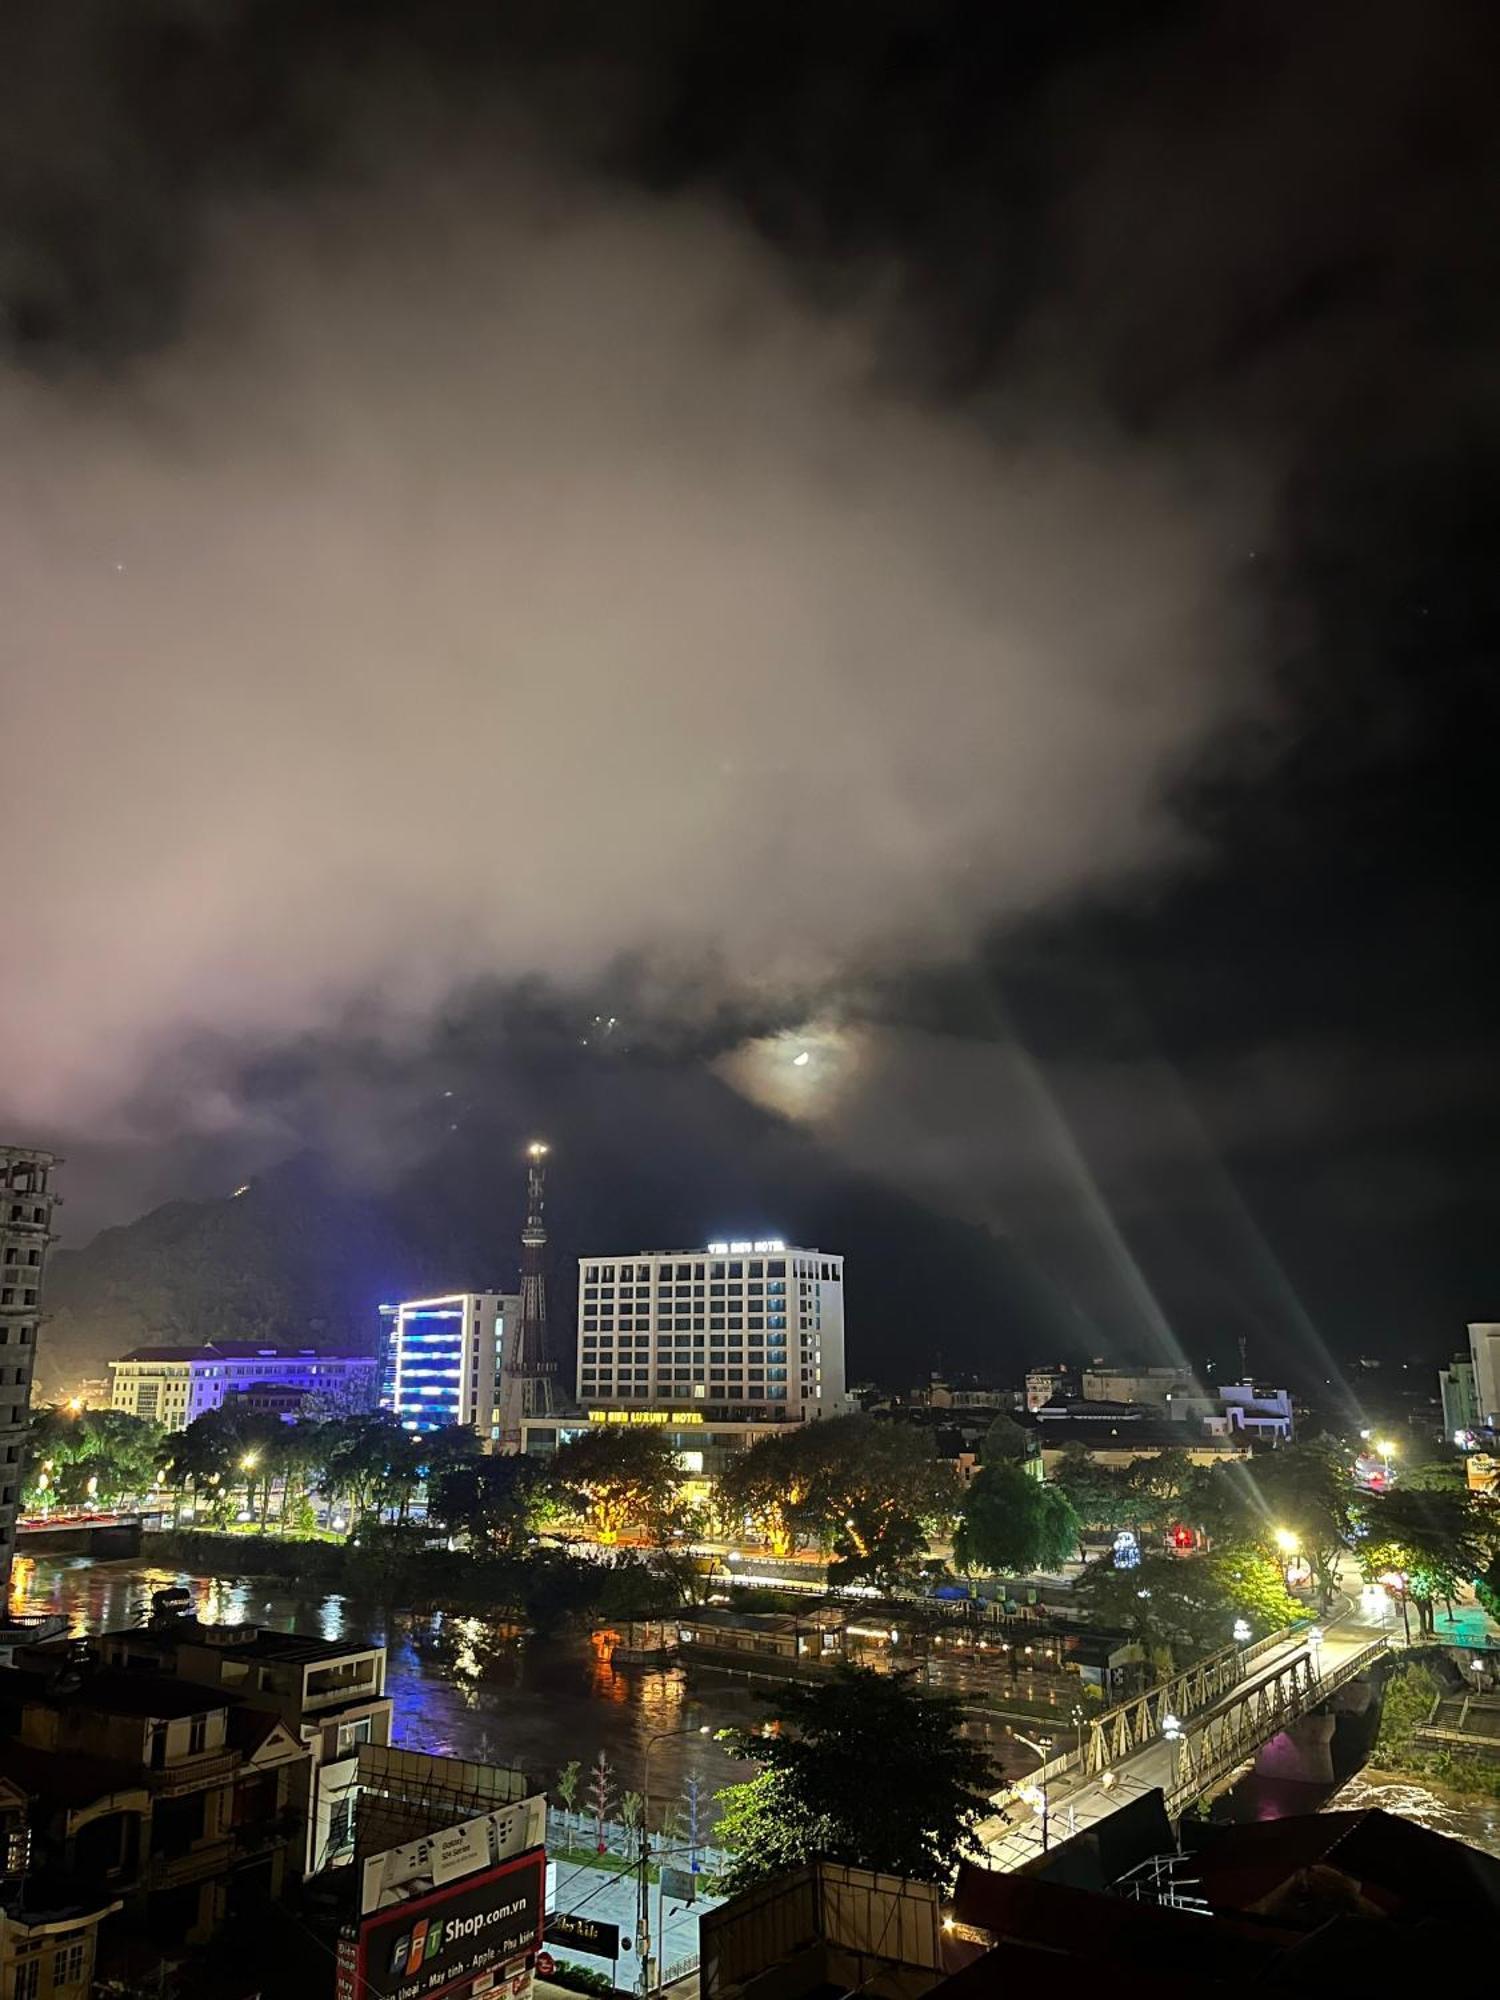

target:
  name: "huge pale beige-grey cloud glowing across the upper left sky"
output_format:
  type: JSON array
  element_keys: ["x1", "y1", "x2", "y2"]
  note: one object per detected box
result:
[{"x1": 0, "y1": 138, "x2": 1252, "y2": 1144}]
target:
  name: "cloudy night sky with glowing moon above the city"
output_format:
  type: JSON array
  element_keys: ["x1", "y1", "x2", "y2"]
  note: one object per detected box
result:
[{"x1": 0, "y1": 0, "x2": 1500, "y2": 1378}]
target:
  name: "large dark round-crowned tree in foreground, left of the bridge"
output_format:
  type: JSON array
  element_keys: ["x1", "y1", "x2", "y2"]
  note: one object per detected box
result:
[{"x1": 716, "y1": 1666, "x2": 992, "y2": 1894}]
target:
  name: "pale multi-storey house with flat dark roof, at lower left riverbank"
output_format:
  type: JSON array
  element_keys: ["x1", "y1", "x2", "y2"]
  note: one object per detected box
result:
[{"x1": 98, "y1": 1616, "x2": 392, "y2": 1874}]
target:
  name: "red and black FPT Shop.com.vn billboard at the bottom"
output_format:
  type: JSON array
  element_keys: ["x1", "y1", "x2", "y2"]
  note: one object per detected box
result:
[{"x1": 338, "y1": 1848, "x2": 544, "y2": 2000}]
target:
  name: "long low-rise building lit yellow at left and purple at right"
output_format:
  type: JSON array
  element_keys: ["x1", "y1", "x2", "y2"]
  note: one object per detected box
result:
[{"x1": 110, "y1": 1340, "x2": 378, "y2": 1430}]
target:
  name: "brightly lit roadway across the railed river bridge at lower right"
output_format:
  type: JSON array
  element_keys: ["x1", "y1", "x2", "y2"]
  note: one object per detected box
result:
[{"x1": 980, "y1": 1580, "x2": 1392, "y2": 1870}]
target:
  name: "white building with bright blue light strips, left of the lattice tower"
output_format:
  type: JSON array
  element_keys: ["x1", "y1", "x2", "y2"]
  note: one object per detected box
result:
[{"x1": 380, "y1": 1292, "x2": 520, "y2": 1440}]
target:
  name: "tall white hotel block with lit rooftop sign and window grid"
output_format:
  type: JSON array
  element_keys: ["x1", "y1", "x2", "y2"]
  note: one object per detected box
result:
[{"x1": 578, "y1": 1238, "x2": 844, "y2": 1424}]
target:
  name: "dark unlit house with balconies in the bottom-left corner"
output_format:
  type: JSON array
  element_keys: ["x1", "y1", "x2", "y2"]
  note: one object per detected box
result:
[{"x1": 0, "y1": 1652, "x2": 308, "y2": 1948}]
